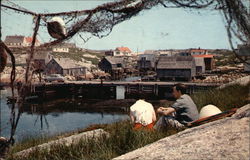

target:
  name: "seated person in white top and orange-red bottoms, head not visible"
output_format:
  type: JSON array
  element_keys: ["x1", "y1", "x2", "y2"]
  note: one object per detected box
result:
[{"x1": 130, "y1": 100, "x2": 156, "y2": 129}]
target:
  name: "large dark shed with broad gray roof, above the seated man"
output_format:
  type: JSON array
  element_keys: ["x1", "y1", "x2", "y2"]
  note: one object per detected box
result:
[{"x1": 156, "y1": 55, "x2": 196, "y2": 80}]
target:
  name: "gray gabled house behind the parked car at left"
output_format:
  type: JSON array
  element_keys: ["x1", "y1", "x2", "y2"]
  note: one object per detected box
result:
[{"x1": 46, "y1": 58, "x2": 86, "y2": 76}]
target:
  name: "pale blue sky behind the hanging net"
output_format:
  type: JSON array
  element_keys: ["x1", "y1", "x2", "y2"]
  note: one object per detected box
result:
[{"x1": 1, "y1": 0, "x2": 233, "y2": 52}]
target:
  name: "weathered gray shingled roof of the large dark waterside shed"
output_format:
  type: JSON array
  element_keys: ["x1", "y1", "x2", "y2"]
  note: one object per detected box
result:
[{"x1": 157, "y1": 56, "x2": 194, "y2": 69}]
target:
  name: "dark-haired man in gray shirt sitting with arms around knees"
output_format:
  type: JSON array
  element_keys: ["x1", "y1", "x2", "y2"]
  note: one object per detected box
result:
[{"x1": 154, "y1": 83, "x2": 199, "y2": 130}]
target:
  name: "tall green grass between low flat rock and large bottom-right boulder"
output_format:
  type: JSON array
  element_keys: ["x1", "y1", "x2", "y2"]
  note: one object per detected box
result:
[{"x1": 7, "y1": 120, "x2": 173, "y2": 160}]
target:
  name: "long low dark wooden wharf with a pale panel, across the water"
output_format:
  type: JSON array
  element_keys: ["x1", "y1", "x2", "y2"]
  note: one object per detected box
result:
[{"x1": 29, "y1": 81, "x2": 221, "y2": 100}]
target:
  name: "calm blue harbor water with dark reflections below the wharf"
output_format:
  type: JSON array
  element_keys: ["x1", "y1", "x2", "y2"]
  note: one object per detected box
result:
[{"x1": 0, "y1": 89, "x2": 128, "y2": 141}]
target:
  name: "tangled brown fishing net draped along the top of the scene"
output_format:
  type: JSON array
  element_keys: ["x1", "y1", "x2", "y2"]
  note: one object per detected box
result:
[{"x1": 3, "y1": 0, "x2": 250, "y2": 46}]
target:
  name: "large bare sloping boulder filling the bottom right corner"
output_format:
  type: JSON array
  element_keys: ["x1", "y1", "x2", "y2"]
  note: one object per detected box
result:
[{"x1": 114, "y1": 104, "x2": 250, "y2": 160}]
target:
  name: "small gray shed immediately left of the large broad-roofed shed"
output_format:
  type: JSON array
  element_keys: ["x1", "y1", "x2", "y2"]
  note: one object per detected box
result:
[{"x1": 137, "y1": 54, "x2": 156, "y2": 70}]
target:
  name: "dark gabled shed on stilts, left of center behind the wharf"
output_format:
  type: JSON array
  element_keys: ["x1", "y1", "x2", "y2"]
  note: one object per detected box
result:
[{"x1": 98, "y1": 56, "x2": 125, "y2": 80}]
